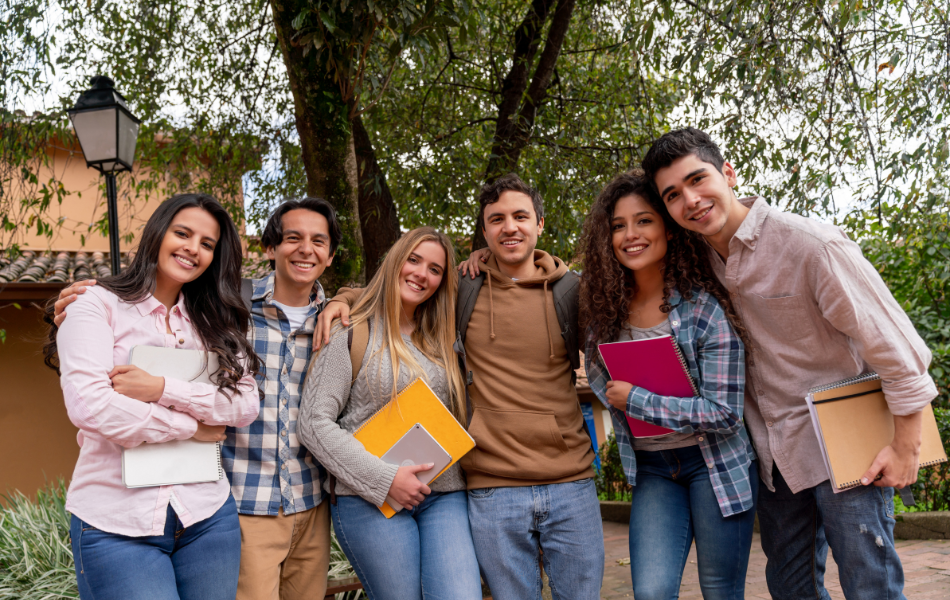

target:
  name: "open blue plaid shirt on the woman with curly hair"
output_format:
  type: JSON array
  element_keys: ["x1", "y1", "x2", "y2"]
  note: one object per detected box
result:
[{"x1": 584, "y1": 290, "x2": 758, "y2": 517}]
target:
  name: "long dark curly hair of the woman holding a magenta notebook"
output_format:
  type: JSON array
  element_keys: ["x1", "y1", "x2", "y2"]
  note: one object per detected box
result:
[{"x1": 578, "y1": 169, "x2": 748, "y2": 346}]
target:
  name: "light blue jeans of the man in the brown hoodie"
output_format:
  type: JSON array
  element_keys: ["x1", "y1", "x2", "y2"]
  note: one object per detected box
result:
[{"x1": 468, "y1": 478, "x2": 604, "y2": 600}]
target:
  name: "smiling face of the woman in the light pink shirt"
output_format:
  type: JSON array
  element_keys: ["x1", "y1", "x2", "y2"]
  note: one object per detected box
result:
[{"x1": 156, "y1": 207, "x2": 221, "y2": 295}]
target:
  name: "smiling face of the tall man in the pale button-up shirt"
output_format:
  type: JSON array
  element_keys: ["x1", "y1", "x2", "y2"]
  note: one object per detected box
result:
[{"x1": 654, "y1": 154, "x2": 745, "y2": 238}]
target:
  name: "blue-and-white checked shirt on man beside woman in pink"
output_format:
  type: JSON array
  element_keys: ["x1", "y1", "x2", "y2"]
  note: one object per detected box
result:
[{"x1": 221, "y1": 273, "x2": 326, "y2": 515}]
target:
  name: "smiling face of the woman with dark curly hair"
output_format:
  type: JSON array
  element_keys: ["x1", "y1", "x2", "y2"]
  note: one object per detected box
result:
[{"x1": 610, "y1": 195, "x2": 670, "y2": 271}]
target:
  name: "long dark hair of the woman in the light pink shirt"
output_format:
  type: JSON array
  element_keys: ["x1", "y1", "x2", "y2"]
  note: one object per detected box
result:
[{"x1": 43, "y1": 194, "x2": 260, "y2": 392}]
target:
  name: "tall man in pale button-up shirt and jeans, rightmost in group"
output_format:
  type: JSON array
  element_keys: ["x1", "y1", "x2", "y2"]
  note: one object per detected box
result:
[{"x1": 643, "y1": 128, "x2": 937, "y2": 600}]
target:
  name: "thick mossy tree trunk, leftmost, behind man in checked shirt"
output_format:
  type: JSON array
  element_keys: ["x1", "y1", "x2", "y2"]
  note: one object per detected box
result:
[{"x1": 271, "y1": 0, "x2": 362, "y2": 293}]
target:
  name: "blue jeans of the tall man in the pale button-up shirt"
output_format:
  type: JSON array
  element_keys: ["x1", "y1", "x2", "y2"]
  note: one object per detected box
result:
[{"x1": 759, "y1": 467, "x2": 904, "y2": 600}]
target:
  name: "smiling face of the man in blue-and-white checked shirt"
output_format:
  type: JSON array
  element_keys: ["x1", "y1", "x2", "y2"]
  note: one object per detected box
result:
[{"x1": 267, "y1": 208, "x2": 333, "y2": 293}]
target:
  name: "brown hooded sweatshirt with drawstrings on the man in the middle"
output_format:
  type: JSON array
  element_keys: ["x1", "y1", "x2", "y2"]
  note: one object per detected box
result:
[{"x1": 461, "y1": 250, "x2": 594, "y2": 489}]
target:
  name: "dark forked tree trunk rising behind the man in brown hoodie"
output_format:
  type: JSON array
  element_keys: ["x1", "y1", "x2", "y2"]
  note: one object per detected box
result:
[{"x1": 472, "y1": 0, "x2": 576, "y2": 250}]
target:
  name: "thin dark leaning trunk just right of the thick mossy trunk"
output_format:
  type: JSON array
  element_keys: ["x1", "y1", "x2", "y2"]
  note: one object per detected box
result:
[{"x1": 351, "y1": 115, "x2": 400, "y2": 281}]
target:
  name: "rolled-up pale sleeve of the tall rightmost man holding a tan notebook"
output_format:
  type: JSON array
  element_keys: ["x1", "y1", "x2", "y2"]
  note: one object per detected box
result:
[{"x1": 809, "y1": 237, "x2": 937, "y2": 415}]
